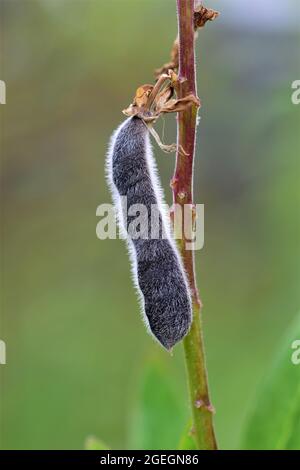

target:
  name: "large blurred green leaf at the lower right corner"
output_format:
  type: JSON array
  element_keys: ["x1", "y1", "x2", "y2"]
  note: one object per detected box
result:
[{"x1": 243, "y1": 316, "x2": 300, "y2": 450}]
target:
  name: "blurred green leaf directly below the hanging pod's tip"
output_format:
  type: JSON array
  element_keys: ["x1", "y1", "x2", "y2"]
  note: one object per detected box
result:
[{"x1": 129, "y1": 358, "x2": 187, "y2": 450}]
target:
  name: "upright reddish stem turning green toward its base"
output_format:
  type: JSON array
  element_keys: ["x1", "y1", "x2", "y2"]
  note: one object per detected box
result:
[{"x1": 172, "y1": 0, "x2": 217, "y2": 450}]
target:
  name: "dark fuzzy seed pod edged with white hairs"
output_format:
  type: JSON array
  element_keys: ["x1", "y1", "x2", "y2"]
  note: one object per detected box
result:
[{"x1": 107, "y1": 117, "x2": 192, "y2": 350}]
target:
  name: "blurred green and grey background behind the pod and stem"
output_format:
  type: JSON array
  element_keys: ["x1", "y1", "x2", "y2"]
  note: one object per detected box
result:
[{"x1": 0, "y1": 0, "x2": 300, "y2": 449}]
